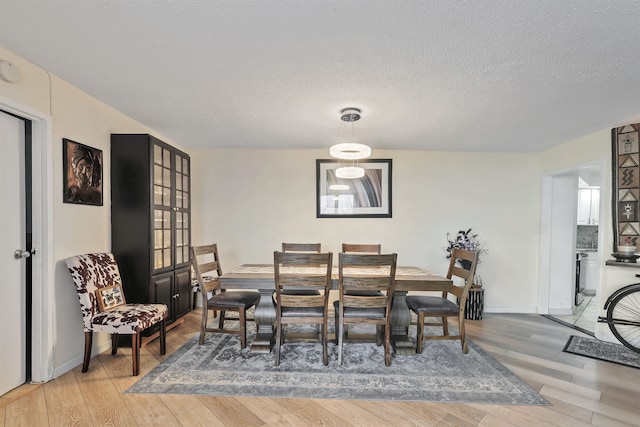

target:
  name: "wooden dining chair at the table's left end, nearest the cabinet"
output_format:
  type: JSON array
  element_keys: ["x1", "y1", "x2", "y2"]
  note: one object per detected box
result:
[{"x1": 191, "y1": 244, "x2": 260, "y2": 348}]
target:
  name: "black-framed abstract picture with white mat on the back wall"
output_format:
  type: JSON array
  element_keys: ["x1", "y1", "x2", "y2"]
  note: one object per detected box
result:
[{"x1": 316, "y1": 159, "x2": 392, "y2": 218}]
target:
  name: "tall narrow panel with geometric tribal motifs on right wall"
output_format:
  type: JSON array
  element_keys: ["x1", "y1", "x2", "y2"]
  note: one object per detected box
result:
[{"x1": 611, "y1": 123, "x2": 640, "y2": 252}]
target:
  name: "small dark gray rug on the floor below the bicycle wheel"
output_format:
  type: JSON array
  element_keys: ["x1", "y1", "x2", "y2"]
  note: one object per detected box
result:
[{"x1": 563, "y1": 335, "x2": 640, "y2": 368}]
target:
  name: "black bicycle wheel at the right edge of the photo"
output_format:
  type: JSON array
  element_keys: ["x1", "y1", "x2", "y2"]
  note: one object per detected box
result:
[{"x1": 607, "y1": 288, "x2": 640, "y2": 353}]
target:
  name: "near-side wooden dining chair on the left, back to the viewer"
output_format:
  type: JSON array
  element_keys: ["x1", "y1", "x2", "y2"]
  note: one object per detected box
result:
[{"x1": 273, "y1": 251, "x2": 333, "y2": 366}]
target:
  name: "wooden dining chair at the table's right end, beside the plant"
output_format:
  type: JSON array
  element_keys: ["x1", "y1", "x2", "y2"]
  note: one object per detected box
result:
[{"x1": 407, "y1": 249, "x2": 478, "y2": 353}]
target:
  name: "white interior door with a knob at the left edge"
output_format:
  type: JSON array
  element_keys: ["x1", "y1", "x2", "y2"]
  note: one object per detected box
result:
[{"x1": 0, "y1": 112, "x2": 26, "y2": 395}]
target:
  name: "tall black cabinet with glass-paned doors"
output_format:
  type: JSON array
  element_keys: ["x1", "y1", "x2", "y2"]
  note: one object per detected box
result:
[{"x1": 111, "y1": 134, "x2": 191, "y2": 323}]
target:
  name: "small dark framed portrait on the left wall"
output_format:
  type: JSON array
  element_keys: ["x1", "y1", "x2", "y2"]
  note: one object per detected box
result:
[{"x1": 62, "y1": 138, "x2": 102, "y2": 206}]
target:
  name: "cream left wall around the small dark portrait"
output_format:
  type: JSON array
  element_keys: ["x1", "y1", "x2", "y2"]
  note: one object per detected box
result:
[{"x1": 0, "y1": 46, "x2": 182, "y2": 376}]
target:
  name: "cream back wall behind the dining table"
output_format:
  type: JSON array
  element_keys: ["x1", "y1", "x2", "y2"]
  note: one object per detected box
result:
[{"x1": 191, "y1": 149, "x2": 540, "y2": 313}]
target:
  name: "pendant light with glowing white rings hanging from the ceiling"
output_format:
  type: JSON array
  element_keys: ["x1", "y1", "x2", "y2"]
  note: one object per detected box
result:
[{"x1": 329, "y1": 108, "x2": 371, "y2": 179}]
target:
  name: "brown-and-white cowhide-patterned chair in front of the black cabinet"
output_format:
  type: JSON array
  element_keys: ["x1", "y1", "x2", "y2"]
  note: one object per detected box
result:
[{"x1": 66, "y1": 253, "x2": 168, "y2": 376}]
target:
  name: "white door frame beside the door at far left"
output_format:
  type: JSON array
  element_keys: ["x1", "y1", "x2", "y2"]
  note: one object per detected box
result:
[{"x1": 0, "y1": 97, "x2": 55, "y2": 383}]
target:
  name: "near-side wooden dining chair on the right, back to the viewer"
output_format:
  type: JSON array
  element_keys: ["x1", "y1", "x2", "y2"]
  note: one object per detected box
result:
[{"x1": 336, "y1": 253, "x2": 398, "y2": 366}]
